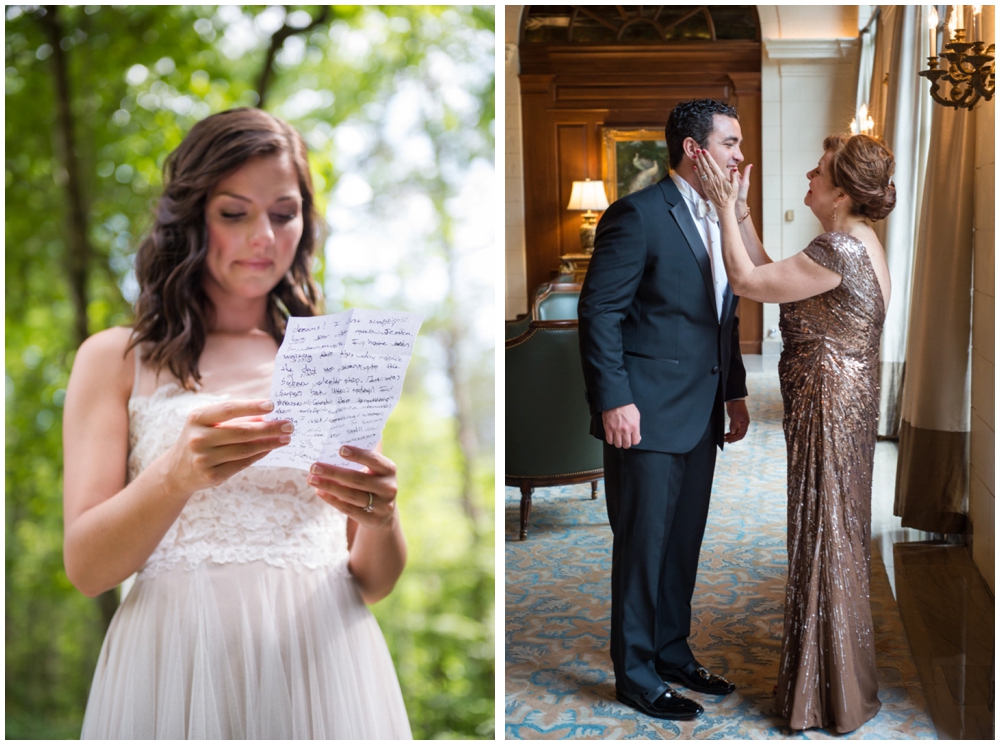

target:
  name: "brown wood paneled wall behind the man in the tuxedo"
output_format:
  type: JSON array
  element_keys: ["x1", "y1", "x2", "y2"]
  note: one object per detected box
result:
[{"x1": 519, "y1": 41, "x2": 763, "y2": 354}]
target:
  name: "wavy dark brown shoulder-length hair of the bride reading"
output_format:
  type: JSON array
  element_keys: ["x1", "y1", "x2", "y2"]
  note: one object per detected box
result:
[{"x1": 129, "y1": 108, "x2": 321, "y2": 390}]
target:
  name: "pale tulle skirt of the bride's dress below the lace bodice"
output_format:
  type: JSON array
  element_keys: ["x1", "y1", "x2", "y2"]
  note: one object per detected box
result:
[{"x1": 81, "y1": 562, "x2": 411, "y2": 739}]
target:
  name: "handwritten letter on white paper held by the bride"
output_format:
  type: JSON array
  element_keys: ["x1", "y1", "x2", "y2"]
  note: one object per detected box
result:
[{"x1": 255, "y1": 308, "x2": 421, "y2": 470}]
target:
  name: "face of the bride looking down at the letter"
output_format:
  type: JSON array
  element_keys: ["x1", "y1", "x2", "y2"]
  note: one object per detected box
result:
[{"x1": 205, "y1": 153, "x2": 303, "y2": 304}]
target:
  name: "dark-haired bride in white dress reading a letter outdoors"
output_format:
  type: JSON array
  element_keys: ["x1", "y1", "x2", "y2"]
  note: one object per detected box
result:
[{"x1": 64, "y1": 109, "x2": 410, "y2": 739}]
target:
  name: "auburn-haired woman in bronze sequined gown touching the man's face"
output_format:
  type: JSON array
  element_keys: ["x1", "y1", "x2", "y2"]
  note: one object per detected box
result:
[{"x1": 699, "y1": 135, "x2": 895, "y2": 733}]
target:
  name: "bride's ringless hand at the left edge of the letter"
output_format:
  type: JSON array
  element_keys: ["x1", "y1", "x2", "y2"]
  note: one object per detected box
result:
[{"x1": 170, "y1": 401, "x2": 294, "y2": 496}]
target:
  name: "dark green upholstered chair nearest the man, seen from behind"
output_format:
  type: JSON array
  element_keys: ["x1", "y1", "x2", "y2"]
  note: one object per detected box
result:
[{"x1": 504, "y1": 320, "x2": 604, "y2": 541}]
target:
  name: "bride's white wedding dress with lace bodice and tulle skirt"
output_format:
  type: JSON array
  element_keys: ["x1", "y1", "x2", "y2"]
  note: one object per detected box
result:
[{"x1": 81, "y1": 354, "x2": 411, "y2": 739}]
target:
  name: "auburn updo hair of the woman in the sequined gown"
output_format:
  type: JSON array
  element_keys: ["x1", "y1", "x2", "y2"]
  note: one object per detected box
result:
[{"x1": 823, "y1": 135, "x2": 896, "y2": 221}]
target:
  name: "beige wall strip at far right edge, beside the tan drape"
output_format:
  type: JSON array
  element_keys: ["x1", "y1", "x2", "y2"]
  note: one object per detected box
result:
[{"x1": 969, "y1": 5, "x2": 996, "y2": 592}]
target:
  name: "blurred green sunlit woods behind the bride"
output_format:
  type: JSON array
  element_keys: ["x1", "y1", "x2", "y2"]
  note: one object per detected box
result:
[{"x1": 4, "y1": 6, "x2": 495, "y2": 739}]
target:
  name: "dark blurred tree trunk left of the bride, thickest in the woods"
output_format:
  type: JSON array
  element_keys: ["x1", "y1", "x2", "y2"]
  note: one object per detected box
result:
[{"x1": 38, "y1": 5, "x2": 118, "y2": 631}]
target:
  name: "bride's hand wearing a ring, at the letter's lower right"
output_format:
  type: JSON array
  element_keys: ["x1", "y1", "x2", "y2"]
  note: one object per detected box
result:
[{"x1": 309, "y1": 445, "x2": 396, "y2": 528}]
